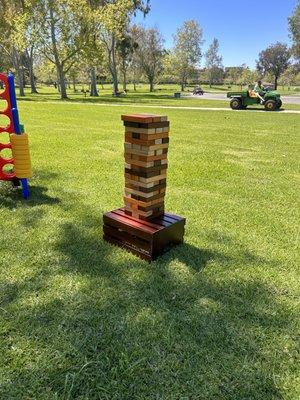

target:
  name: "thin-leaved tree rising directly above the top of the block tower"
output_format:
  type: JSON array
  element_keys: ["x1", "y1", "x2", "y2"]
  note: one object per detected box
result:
[{"x1": 134, "y1": 26, "x2": 164, "y2": 92}]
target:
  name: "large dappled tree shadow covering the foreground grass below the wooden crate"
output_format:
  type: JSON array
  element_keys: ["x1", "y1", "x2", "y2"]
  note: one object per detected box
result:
[{"x1": 0, "y1": 210, "x2": 293, "y2": 400}]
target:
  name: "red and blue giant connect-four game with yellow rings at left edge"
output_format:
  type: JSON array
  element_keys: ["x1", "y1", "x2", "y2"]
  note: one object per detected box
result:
[{"x1": 0, "y1": 73, "x2": 32, "y2": 199}]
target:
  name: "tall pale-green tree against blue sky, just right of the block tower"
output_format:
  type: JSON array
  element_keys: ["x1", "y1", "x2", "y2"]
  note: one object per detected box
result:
[{"x1": 170, "y1": 20, "x2": 203, "y2": 91}]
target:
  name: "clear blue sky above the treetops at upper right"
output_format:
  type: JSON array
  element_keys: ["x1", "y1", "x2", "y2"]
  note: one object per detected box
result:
[{"x1": 135, "y1": 0, "x2": 297, "y2": 68}]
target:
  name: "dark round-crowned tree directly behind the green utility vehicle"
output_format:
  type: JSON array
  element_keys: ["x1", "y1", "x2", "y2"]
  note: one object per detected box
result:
[{"x1": 256, "y1": 42, "x2": 291, "y2": 90}]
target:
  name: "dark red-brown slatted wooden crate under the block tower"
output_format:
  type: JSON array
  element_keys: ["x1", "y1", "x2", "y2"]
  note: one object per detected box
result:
[{"x1": 103, "y1": 208, "x2": 185, "y2": 262}]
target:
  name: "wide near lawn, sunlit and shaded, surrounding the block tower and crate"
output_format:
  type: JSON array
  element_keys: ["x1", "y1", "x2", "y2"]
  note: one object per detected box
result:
[{"x1": 0, "y1": 101, "x2": 300, "y2": 400}]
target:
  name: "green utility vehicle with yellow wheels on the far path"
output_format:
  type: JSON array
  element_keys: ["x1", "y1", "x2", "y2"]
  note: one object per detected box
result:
[{"x1": 227, "y1": 90, "x2": 282, "y2": 111}]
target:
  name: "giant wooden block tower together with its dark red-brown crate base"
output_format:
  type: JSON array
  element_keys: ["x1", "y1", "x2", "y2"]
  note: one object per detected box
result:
[{"x1": 103, "y1": 114, "x2": 185, "y2": 261}]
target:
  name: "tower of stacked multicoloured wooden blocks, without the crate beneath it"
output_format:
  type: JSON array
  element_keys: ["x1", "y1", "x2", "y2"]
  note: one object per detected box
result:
[{"x1": 122, "y1": 114, "x2": 170, "y2": 220}]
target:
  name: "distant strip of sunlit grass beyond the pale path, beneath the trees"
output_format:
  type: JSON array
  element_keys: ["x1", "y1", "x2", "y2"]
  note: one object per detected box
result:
[{"x1": 15, "y1": 85, "x2": 300, "y2": 110}]
